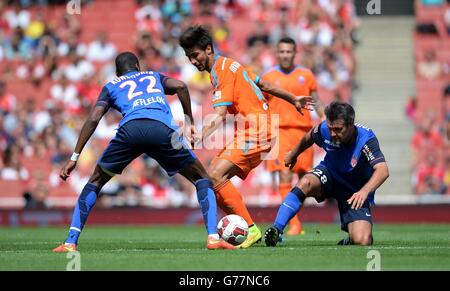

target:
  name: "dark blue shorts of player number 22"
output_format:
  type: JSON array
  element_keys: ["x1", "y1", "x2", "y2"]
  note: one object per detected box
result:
[{"x1": 98, "y1": 119, "x2": 196, "y2": 176}]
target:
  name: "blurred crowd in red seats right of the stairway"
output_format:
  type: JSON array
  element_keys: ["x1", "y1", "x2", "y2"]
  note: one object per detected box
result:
[{"x1": 412, "y1": 0, "x2": 450, "y2": 195}]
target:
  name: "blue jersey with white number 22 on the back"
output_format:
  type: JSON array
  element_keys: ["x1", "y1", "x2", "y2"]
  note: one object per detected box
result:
[{"x1": 97, "y1": 71, "x2": 177, "y2": 130}]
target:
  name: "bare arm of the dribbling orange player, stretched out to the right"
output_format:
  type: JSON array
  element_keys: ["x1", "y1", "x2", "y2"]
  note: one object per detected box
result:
[{"x1": 257, "y1": 80, "x2": 315, "y2": 115}]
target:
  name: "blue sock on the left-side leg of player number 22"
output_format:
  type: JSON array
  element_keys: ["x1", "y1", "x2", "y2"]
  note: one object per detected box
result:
[{"x1": 66, "y1": 183, "x2": 99, "y2": 244}]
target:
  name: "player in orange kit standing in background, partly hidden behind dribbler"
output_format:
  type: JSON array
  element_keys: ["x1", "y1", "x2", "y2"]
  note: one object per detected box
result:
[{"x1": 261, "y1": 37, "x2": 324, "y2": 235}]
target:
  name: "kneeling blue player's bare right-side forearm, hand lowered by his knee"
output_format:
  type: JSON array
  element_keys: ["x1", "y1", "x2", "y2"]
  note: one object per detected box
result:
[{"x1": 347, "y1": 162, "x2": 389, "y2": 209}]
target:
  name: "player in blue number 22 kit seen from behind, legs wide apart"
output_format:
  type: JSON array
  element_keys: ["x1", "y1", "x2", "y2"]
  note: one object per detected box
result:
[{"x1": 53, "y1": 52, "x2": 235, "y2": 252}]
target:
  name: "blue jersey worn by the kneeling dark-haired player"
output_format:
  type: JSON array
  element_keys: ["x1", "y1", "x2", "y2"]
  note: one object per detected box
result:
[{"x1": 312, "y1": 121, "x2": 385, "y2": 198}]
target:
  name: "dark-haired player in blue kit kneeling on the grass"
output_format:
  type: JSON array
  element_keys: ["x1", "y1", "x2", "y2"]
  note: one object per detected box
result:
[{"x1": 264, "y1": 101, "x2": 389, "y2": 246}]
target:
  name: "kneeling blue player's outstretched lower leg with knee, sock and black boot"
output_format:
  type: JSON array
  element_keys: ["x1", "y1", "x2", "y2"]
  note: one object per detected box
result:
[{"x1": 264, "y1": 173, "x2": 321, "y2": 246}]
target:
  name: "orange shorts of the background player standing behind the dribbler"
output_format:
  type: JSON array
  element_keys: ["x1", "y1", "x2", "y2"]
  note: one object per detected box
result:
[{"x1": 266, "y1": 128, "x2": 314, "y2": 173}]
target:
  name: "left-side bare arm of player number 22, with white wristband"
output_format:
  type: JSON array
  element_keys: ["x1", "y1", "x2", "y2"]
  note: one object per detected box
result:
[{"x1": 59, "y1": 105, "x2": 108, "y2": 181}]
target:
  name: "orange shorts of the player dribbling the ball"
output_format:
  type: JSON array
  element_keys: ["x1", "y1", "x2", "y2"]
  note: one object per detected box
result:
[{"x1": 211, "y1": 143, "x2": 270, "y2": 180}]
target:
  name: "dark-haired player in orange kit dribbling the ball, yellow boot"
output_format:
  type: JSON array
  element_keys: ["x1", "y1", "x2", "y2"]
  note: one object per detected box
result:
[{"x1": 179, "y1": 26, "x2": 313, "y2": 248}]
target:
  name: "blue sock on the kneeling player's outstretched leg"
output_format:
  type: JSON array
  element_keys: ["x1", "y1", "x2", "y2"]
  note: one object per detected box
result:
[{"x1": 273, "y1": 187, "x2": 306, "y2": 233}]
